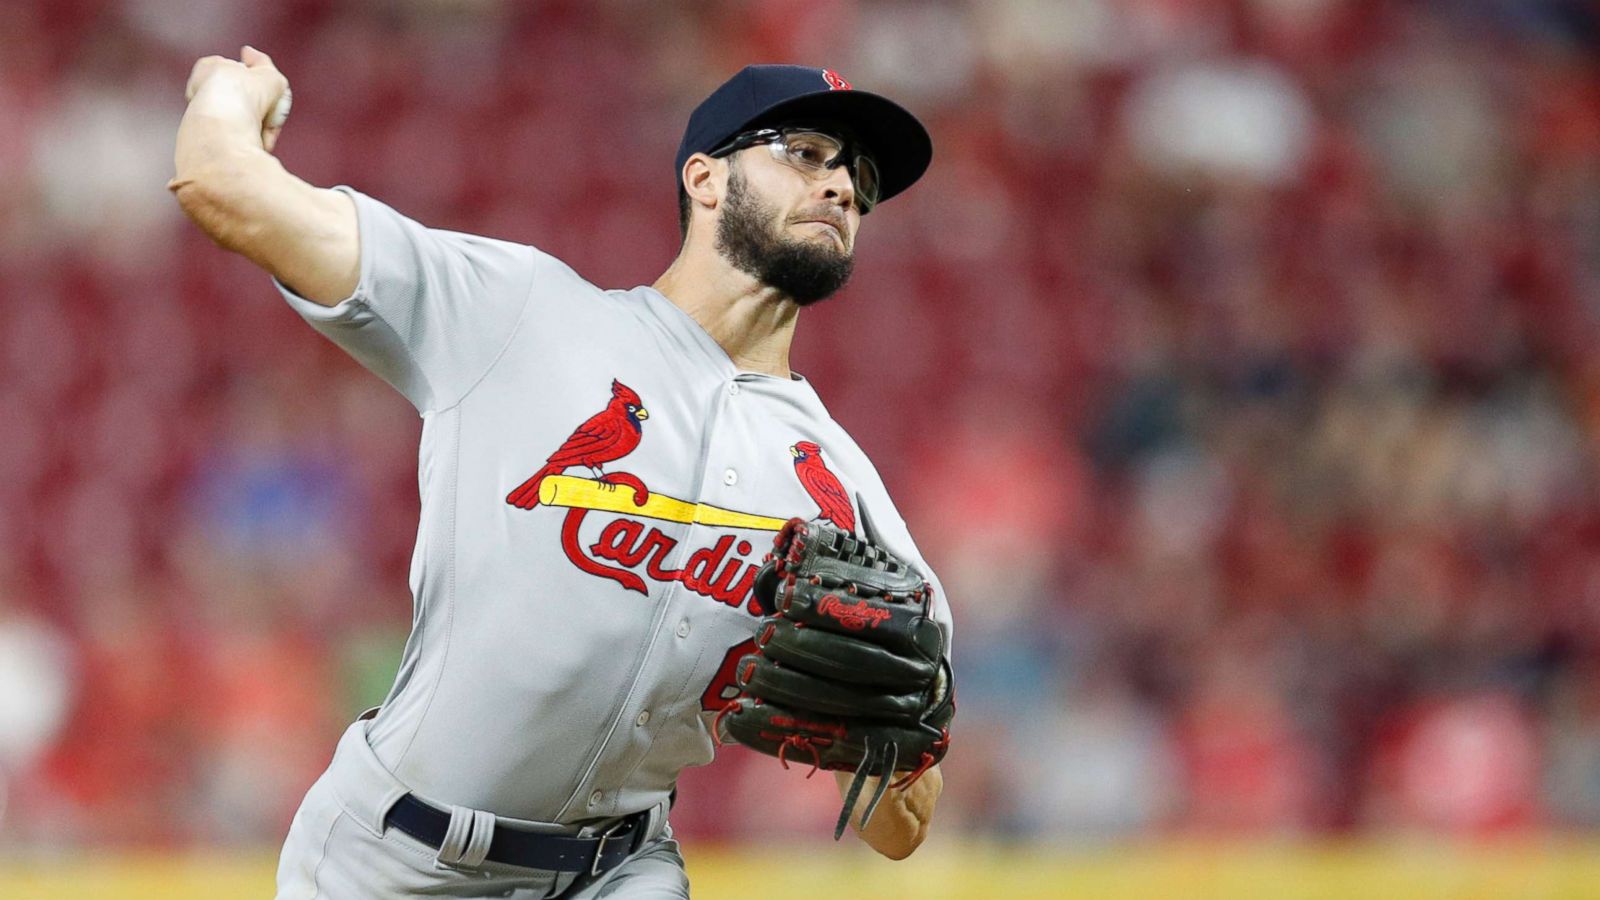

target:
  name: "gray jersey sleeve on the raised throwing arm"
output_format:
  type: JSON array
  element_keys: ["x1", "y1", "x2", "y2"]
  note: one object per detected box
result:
[{"x1": 274, "y1": 187, "x2": 544, "y2": 412}]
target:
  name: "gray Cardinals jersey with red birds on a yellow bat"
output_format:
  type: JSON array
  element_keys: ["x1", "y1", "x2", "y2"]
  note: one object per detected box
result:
[{"x1": 280, "y1": 189, "x2": 949, "y2": 823}]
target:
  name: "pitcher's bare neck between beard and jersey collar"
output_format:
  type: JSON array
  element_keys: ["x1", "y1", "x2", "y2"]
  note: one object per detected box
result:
[{"x1": 651, "y1": 247, "x2": 800, "y2": 378}]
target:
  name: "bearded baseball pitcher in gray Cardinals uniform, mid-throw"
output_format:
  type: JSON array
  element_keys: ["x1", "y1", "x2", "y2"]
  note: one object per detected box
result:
[{"x1": 170, "y1": 46, "x2": 954, "y2": 898}]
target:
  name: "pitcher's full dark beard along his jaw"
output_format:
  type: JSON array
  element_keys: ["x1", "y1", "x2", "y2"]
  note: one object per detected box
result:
[{"x1": 717, "y1": 167, "x2": 856, "y2": 306}]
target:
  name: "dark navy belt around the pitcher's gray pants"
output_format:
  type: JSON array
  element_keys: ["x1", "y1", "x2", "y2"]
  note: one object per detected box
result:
[{"x1": 384, "y1": 794, "x2": 650, "y2": 874}]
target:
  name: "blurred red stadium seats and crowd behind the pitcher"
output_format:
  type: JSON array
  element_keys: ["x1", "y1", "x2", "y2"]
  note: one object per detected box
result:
[{"x1": 0, "y1": 0, "x2": 1600, "y2": 847}]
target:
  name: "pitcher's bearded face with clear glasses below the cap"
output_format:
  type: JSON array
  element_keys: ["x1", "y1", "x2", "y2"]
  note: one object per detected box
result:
[{"x1": 717, "y1": 146, "x2": 861, "y2": 306}]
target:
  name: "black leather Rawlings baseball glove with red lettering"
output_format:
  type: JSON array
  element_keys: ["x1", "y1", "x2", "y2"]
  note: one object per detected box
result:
[{"x1": 714, "y1": 519, "x2": 955, "y2": 841}]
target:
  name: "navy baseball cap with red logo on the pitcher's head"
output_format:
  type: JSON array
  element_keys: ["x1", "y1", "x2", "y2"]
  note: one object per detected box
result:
[{"x1": 677, "y1": 66, "x2": 933, "y2": 203}]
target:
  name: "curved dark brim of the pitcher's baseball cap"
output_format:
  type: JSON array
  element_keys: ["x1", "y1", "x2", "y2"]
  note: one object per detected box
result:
[{"x1": 739, "y1": 90, "x2": 933, "y2": 203}]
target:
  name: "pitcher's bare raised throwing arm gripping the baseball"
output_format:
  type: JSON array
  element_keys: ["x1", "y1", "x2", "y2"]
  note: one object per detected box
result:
[{"x1": 168, "y1": 46, "x2": 360, "y2": 306}]
